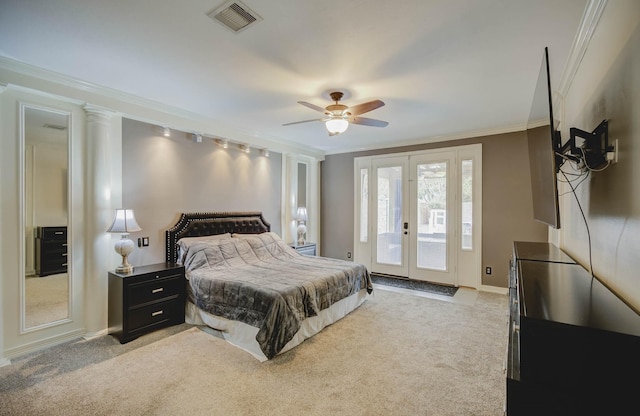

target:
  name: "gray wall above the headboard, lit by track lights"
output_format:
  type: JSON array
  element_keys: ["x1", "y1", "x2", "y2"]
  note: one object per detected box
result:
[{"x1": 122, "y1": 119, "x2": 282, "y2": 266}]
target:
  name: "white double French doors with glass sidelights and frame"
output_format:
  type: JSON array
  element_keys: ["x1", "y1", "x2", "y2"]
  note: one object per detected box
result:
[{"x1": 354, "y1": 145, "x2": 482, "y2": 288}]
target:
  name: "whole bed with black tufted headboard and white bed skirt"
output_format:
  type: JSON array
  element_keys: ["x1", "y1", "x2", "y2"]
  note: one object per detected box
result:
[{"x1": 166, "y1": 212, "x2": 373, "y2": 361}]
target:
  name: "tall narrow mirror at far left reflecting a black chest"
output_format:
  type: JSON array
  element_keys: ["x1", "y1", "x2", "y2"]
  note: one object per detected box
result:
[{"x1": 21, "y1": 104, "x2": 70, "y2": 330}]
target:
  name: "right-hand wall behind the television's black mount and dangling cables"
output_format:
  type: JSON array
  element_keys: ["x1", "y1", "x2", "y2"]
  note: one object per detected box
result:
[{"x1": 558, "y1": 1, "x2": 640, "y2": 310}]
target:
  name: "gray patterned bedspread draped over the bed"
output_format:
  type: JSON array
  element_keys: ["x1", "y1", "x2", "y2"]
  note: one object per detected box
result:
[{"x1": 179, "y1": 232, "x2": 373, "y2": 359}]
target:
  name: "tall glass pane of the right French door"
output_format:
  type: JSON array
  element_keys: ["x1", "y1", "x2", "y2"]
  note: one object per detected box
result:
[{"x1": 416, "y1": 162, "x2": 447, "y2": 270}]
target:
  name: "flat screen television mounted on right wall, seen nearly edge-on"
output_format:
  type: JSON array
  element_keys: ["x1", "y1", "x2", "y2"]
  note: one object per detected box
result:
[{"x1": 527, "y1": 48, "x2": 560, "y2": 228}]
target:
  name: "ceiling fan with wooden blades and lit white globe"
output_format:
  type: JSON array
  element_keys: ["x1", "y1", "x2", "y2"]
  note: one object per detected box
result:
[{"x1": 283, "y1": 91, "x2": 389, "y2": 136}]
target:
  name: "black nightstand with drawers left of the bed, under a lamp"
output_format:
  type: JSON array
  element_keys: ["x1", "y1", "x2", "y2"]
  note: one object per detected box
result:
[{"x1": 109, "y1": 263, "x2": 185, "y2": 344}]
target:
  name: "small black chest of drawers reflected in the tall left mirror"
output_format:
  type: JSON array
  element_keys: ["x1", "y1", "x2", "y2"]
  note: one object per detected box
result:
[{"x1": 36, "y1": 227, "x2": 68, "y2": 277}]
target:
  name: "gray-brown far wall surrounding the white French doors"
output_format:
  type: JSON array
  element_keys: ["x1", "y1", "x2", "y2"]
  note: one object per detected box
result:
[{"x1": 321, "y1": 132, "x2": 548, "y2": 287}]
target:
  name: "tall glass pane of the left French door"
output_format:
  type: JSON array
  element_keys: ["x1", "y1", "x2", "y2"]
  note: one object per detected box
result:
[{"x1": 376, "y1": 166, "x2": 402, "y2": 265}]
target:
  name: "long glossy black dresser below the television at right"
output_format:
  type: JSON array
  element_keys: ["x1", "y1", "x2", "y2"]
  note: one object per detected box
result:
[{"x1": 506, "y1": 242, "x2": 640, "y2": 416}]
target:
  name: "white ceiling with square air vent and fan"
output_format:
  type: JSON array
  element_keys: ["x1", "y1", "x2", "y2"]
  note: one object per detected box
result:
[{"x1": 0, "y1": 0, "x2": 587, "y2": 153}]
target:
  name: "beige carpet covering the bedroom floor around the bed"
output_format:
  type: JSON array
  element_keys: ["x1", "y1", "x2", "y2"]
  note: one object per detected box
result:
[{"x1": 0, "y1": 290, "x2": 507, "y2": 416}]
